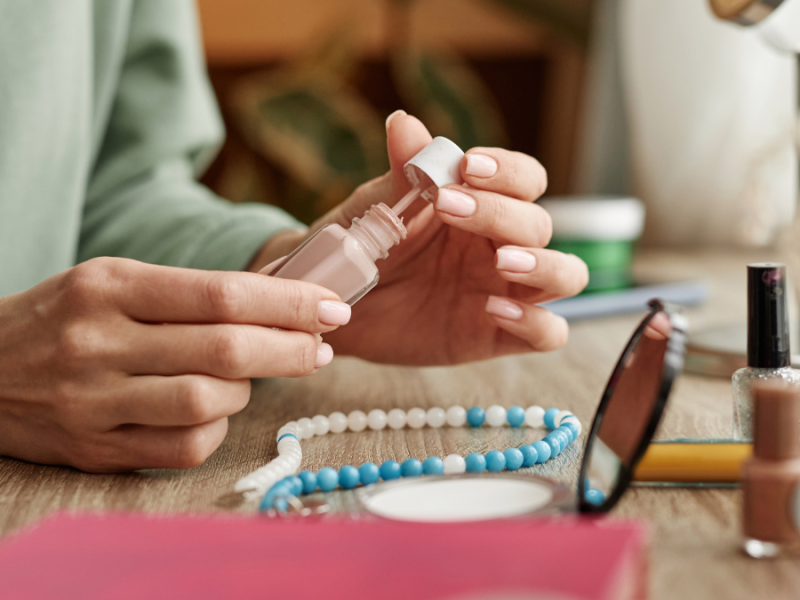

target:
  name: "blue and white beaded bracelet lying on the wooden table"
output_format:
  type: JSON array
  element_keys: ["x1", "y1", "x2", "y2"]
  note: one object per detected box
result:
[{"x1": 235, "y1": 405, "x2": 582, "y2": 509}]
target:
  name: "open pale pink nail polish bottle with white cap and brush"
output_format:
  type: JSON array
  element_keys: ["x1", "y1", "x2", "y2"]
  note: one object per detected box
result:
[{"x1": 269, "y1": 137, "x2": 464, "y2": 305}]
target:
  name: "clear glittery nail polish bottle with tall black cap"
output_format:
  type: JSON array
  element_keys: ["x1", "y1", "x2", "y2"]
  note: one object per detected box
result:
[{"x1": 733, "y1": 263, "x2": 800, "y2": 440}]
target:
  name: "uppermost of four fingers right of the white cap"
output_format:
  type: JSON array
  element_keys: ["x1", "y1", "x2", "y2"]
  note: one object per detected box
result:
[{"x1": 461, "y1": 148, "x2": 547, "y2": 202}]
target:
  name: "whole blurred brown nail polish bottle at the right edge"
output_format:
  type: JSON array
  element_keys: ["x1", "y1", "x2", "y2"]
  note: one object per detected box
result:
[{"x1": 741, "y1": 381, "x2": 800, "y2": 558}]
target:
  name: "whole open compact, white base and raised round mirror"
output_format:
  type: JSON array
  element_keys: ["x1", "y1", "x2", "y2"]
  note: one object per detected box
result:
[{"x1": 356, "y1": 300, "x2": 686, "y2": 522}]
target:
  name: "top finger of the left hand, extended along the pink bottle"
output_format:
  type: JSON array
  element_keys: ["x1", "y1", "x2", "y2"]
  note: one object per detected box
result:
[{"x1": 103, "y1": 261, "x2": 350, "y2": 333}]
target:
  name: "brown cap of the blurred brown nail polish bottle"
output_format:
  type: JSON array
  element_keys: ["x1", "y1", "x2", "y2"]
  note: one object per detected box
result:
[{"x1": 753, "y1": 381, "x2": 800, "y2": 460}]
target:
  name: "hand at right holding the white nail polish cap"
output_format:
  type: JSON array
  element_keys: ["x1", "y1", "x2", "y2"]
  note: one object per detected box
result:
[{"x1": 253, "y1": 112, "x2": 588, "y2": 365}]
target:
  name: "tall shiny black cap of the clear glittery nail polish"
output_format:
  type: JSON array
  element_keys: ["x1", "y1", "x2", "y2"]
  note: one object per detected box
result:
[{"x1": 747, "y1": 263, "x2": 790, "y2": 369}]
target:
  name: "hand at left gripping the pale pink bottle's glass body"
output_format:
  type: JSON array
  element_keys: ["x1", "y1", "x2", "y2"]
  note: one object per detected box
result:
[{"x1": 0, "y1": 258, "x2": 350, "y2": 472}]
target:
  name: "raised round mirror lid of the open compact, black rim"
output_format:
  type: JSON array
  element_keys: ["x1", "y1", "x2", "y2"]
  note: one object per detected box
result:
[{"x1": 578, "y1": 300, "x2": 685, "y2": 512}]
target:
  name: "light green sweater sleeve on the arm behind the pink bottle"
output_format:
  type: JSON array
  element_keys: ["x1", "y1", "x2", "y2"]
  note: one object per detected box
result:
[{"x1": 78, "y1": 0, "x2": 301, "y2": 270}]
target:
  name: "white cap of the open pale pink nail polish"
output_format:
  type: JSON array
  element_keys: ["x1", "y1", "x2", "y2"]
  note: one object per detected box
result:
[{"x1": 403, "y1": 137, "x2": 464, "y2": 202}]
